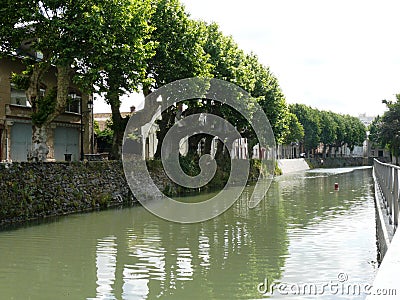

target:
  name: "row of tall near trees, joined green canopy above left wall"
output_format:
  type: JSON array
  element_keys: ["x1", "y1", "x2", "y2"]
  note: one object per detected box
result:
[{"x1": 0, "y1": 0, "x2": 312, "y2": 162}]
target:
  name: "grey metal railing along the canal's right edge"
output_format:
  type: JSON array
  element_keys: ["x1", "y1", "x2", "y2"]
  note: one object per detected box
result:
[{"x1": 374, "y1": 159, "x2": 400, "y2": 231}]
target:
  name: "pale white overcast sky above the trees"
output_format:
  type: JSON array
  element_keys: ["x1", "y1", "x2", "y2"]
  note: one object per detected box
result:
[{"x1": 98, "y1": 0, "x2": 400, "y2": 116}]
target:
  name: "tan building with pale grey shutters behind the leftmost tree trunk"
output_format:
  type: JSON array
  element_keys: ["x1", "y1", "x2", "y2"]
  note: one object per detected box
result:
[{"x1": 0, "y1": 57, "x2": 93, "y2": 161}]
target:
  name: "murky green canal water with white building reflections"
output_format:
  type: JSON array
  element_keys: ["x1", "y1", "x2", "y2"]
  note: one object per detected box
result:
[{"x1": 0, "y1": 168, "x2": 377, "y2": 299}]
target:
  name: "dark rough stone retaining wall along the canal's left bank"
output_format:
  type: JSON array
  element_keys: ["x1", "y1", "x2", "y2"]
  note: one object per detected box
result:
[{"x1": 0, "y1": 161, "x2": 259, "y2": 228}]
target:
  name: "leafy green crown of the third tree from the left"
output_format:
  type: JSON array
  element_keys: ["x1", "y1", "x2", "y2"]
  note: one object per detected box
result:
[{"x1": 144, "y1": 0, "x2": 211, "y2": 95}]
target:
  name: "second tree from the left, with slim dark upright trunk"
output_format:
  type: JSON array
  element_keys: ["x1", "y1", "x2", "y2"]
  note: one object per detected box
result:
[{"x1": 78, "y1": 0, "x2": 156, "y2": 159}]
